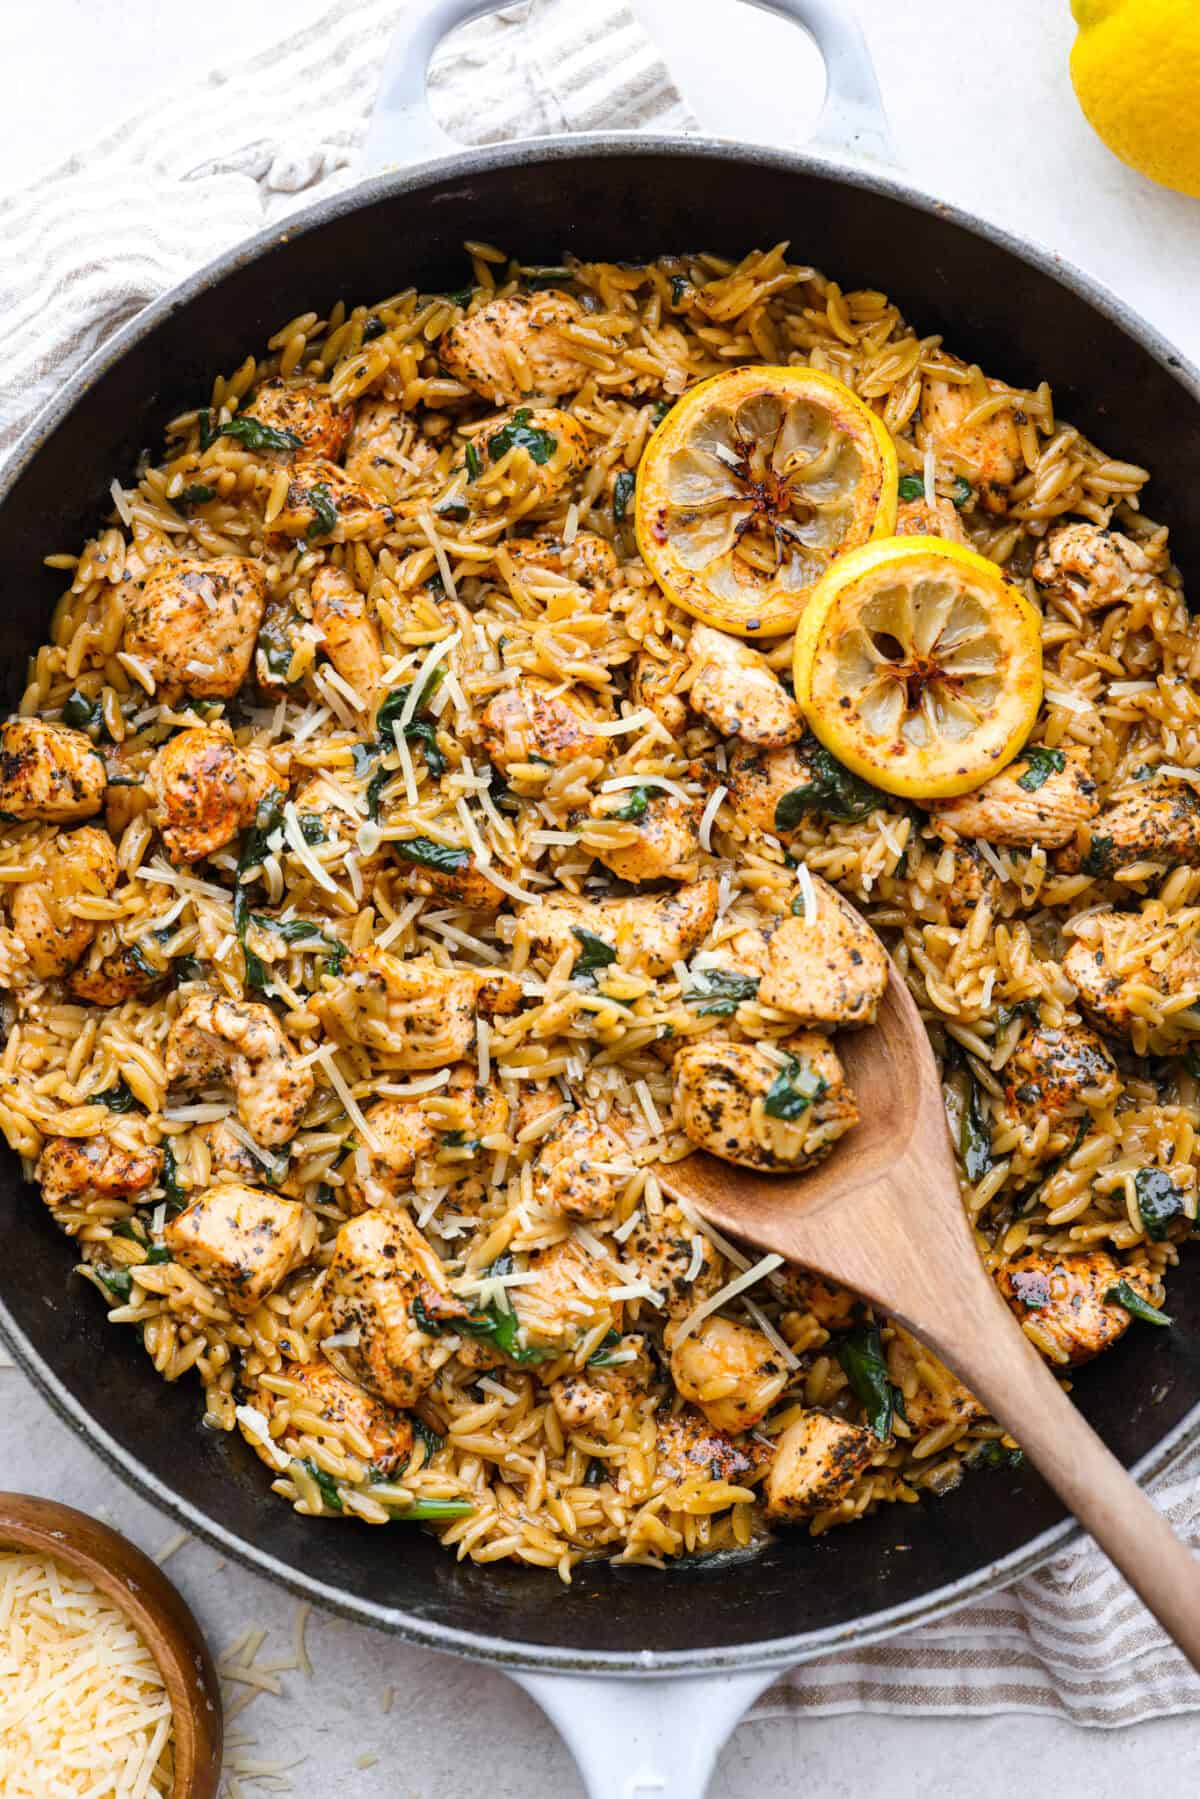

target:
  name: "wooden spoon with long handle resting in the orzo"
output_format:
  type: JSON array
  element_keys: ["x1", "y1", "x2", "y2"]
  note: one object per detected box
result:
[{"x1": 658, "y1": 962, "x2": 1200, "y2": 1669}]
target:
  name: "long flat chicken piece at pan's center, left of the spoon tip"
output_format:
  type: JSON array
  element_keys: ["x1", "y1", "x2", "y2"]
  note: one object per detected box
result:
[{"x1": 518, "y1": 878, "x2": 716, "y2": 975}]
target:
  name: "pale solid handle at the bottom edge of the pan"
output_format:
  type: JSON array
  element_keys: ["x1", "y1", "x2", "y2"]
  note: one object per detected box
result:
[{"x1": 513, "y1": 1668, "x2": 779, "y2": 1799}]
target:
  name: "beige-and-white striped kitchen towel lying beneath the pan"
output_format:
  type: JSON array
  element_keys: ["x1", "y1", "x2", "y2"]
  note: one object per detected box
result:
[{"x1": 0, "y1": 0, "x2": 1200, "y2": 1725}]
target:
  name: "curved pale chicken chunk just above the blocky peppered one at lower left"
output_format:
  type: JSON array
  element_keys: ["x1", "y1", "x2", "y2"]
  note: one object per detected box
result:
[{"x1": 166, "y1": 989, "x2": 315, "y2": 1150}]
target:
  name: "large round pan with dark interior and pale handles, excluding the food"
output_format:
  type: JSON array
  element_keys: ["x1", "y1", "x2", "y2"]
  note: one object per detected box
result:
[{"x1": 0, "y1": 0, "x2": 1200, "y2": 1799}]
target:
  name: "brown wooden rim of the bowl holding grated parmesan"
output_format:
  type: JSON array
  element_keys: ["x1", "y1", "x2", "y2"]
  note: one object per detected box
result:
[{"x1": 0, "y1": 1493, "x2": 225, "y2": 1799}]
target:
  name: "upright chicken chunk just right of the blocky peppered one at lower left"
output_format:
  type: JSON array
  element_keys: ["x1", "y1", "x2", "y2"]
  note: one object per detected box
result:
[{"x1": 326, "y1": 1211, "x2": 468, "y2": 1407}]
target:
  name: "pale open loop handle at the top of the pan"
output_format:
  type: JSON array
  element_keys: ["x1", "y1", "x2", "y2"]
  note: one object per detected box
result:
[{"x1": 362, "y1": 0, "x2": 896, "y2": 175}]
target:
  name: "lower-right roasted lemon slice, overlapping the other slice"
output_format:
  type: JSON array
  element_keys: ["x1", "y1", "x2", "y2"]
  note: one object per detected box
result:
[{"x1": 795, "y1": 538, "x2": 1042, "y2": 799}]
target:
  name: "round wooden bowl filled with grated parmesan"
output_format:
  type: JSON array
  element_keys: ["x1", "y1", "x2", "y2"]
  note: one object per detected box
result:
[{"x1": 0, "y1": 1493, "x2": 221, "y2": 1799}]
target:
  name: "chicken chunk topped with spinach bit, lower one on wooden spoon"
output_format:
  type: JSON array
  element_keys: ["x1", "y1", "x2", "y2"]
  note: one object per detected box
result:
[{"x1": 675, "y1": 1031, "x2": 858, "y2": 1173}]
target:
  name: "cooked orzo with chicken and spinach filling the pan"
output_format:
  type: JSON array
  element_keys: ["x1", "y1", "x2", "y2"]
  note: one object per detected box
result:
[{"x1": 0, "y1": 245, "x2": 1200, "y2": 1580}]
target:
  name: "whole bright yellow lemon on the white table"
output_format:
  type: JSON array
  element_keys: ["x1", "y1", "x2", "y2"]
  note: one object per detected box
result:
[{"x1": 1070, "y1": 0, "x2": 1200, "y2": 196}]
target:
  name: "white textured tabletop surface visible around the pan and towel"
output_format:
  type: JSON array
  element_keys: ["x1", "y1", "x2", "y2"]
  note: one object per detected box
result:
[{"x1": 0, "y1": 0, "x2": 1200, "y2": 1799}]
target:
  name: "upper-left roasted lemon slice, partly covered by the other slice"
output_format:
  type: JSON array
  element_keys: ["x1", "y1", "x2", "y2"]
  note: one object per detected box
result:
[{"x1": 637, "y1": 365, "x2": 896, "y2": 637}]
